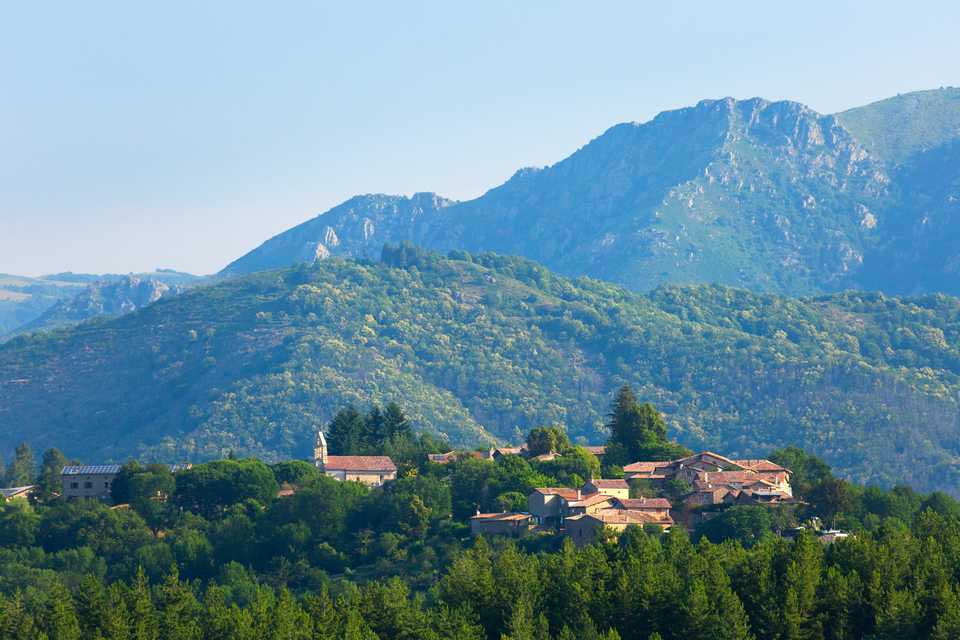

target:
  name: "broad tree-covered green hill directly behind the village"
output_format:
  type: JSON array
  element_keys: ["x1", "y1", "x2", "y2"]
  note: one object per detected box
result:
[{"x1": 0, "y1": 247, "x2": 960, "y2": 494}]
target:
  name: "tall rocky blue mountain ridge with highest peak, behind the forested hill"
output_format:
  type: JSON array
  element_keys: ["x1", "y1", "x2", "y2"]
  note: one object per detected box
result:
[{"x1": 224, "y1": 89, "x2": 960, "y2": 295}]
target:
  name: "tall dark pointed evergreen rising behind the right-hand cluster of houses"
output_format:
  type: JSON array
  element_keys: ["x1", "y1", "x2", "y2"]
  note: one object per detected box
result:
[{"x1": 604, "y1": 385, "x2": 690, "y2": 464}]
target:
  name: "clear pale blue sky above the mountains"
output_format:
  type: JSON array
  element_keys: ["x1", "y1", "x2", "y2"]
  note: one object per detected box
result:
[{"x1": 0, "y1": 0, "x2": 960, "y2": 275}]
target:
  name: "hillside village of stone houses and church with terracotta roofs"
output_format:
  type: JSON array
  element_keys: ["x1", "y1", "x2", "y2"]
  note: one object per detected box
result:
[{"x1": 0, "y1": 430, "x2": 843, "y2": 546}]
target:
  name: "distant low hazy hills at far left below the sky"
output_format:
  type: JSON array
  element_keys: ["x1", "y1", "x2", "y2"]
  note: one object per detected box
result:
[{"x1": 0, "y1": 269, "x2": 206, "y2": 340}]
